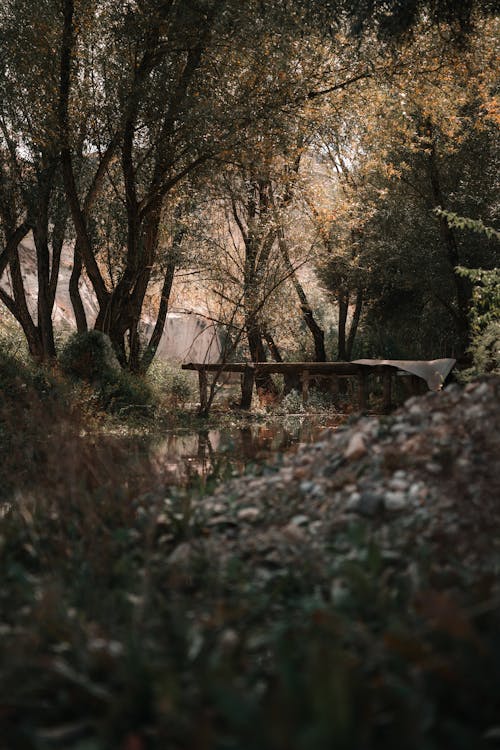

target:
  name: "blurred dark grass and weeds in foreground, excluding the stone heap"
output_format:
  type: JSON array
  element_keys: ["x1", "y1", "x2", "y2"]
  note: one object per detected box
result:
[{"x1": 0, "y1": 356, "x2": 500, "y2": 750}]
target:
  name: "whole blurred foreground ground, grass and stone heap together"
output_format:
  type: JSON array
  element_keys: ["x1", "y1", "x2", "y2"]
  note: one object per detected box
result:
[{"x1": 0, "y1": 362, "x2": 500, "y2": 750}]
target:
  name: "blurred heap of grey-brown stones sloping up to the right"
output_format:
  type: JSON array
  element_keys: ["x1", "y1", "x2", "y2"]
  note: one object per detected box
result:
[{"x1": 165, "y1": 378, "x2": 500, "y2": 584}]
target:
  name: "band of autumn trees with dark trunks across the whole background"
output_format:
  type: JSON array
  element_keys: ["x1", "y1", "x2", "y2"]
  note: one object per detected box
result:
[{"x1": 0, "y1": 0, "x2": 498, "y2": 370}]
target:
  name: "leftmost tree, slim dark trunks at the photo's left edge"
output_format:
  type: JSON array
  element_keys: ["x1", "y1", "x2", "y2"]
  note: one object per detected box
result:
[{"x1": 0, "y1": 0, "x2": 71, "y2": 359}]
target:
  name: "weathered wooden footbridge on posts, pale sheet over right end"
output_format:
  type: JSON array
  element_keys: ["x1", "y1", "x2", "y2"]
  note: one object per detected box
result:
[{"x1": 182, "y1": 359, "x2": 455, "y2": 411}]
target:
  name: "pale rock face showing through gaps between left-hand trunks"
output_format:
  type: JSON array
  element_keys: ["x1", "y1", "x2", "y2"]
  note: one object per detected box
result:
[{"x1": 0, "y1": 234, "x2": 222, "y2": 363}]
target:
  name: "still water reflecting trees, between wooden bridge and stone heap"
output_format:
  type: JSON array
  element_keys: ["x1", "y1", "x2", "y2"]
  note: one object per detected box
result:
[{"x1": 154, "y1": 417, "x2": 338, "y2": 484}]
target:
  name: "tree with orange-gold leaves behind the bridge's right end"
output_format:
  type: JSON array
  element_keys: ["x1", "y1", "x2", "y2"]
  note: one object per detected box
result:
[{"x1": 310, "y1": 14, "x2": 497, "y2": 357}]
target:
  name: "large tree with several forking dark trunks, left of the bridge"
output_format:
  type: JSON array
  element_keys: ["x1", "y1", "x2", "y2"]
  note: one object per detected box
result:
[{"x1": 59, "y1": 0, "x2": 352, "y2": 369}]
